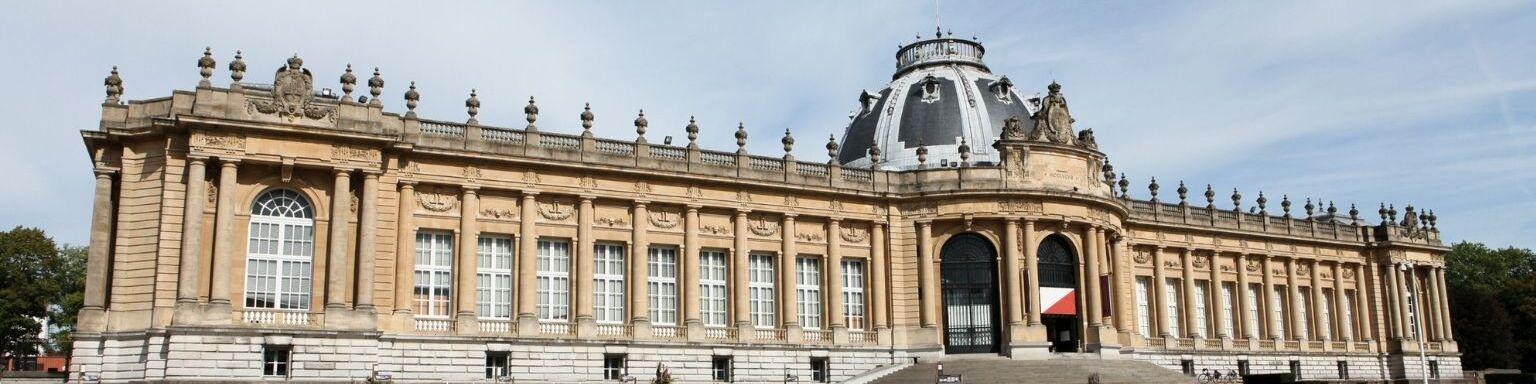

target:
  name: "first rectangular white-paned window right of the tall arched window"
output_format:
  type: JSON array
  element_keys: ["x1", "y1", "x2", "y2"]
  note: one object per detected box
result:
[{"x1": 415, "y1": 232, "x2": 453, "y2": 318}]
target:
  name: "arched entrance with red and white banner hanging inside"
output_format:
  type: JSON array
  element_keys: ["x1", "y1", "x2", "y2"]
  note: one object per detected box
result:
[{"x1": 1035, "y1": 235, "x2": 1083, "y2": 352}]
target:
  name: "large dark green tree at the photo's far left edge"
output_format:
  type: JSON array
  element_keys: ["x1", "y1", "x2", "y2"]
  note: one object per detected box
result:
[{"x1": 0, "y1": 226, "x2": 61, "y2": 364}]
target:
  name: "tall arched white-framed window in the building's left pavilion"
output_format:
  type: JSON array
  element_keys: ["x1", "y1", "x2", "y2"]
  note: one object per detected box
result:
[{"x1": 246, "y1": 189, "x2": 315, "y2": 310}]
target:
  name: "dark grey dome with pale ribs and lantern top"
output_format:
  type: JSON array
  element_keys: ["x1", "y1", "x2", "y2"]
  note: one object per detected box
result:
[{"x1": 837, "y1": 35, "x2": 1035, "y2": 169}]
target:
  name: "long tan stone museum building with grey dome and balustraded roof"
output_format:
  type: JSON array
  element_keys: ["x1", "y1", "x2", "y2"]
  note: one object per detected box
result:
[{"x1": 71, "y1": 34, "x2": 1461, "y2": 382}]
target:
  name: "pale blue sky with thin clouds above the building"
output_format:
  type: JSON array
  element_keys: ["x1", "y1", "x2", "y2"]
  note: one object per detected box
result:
[{"x1": 0, "y1": 0, "x2": 1536, "y2": 247}]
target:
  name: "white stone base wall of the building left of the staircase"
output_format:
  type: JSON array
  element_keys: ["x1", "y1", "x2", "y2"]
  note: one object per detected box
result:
[{"x1": 71, "y1": 329, "x2": 911, "y2": 382}]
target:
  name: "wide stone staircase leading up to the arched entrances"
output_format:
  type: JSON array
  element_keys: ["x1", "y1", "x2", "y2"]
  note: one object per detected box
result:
[{"x1": 872, "y1": 355, "x2": 1197, "y2": 384}]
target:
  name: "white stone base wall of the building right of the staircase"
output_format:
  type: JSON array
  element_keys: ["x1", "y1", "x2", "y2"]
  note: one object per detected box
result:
[{"x1": 1134, "y1": 352, "x2": 1462, "y2": 379}]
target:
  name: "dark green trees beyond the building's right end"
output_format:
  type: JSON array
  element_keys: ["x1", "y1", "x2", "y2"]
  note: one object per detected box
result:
[{"x1": 1445, "y1": 243, "x2": 1536, "y2": 372}]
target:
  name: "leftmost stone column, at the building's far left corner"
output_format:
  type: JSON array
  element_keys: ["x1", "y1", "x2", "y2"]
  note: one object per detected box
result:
[{"x1": 80, "y1": 167, "x2": 117, "y2": 332}]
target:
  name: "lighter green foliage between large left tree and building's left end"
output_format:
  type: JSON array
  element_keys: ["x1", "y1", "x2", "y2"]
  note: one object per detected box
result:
[{"x1": 48, "y1": 244, "x2": 89, "y2": 356}]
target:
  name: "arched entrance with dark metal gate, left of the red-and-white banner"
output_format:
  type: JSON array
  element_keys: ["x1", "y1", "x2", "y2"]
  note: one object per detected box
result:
[{"x1": 938, "y1": 233, "x2": 998, "y2": 353}]
